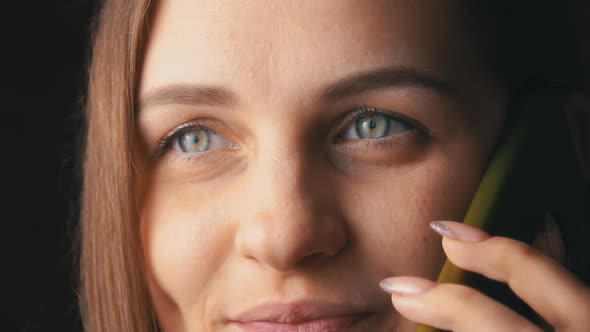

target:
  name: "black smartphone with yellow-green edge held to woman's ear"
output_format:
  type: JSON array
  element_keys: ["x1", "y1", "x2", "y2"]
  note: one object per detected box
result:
[{"x1": 417, "y1": 89, "x2": 590, "y2": 332}]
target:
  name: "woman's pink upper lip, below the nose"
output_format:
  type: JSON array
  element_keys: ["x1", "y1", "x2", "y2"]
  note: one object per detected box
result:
[{"x1": 230, "y1": 300, "x2": 370, "y2": 324}]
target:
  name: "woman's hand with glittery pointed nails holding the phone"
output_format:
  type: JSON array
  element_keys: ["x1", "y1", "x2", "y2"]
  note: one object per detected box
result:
[{"x1": 381, "y1": 221, "x2": 590, "y2": 332}]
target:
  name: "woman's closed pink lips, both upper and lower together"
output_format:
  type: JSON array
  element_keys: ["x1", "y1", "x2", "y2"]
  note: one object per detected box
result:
[{"x1": 228, "y1": 301, "x2": 373, "y2": 332}]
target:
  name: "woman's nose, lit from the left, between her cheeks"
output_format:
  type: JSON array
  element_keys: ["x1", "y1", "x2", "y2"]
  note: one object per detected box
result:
[{"x1": 235, "y1": 148, "x2": 348, "y2": 273}]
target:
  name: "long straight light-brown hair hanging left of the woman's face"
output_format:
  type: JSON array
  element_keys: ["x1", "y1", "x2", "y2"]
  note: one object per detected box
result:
[{"x1": 79, "y1": 0, "x2": 156, "y2": 332}]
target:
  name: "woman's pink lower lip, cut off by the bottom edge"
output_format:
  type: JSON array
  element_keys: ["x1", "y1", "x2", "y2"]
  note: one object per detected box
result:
[{"x1": 233, "y1": 315, "x2": 368, "y2": 332}]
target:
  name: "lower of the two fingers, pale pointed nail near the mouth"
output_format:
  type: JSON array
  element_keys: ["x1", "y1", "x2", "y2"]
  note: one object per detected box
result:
[{"x1": 382, "y1": 277, "x2": 541, "y2": 332}]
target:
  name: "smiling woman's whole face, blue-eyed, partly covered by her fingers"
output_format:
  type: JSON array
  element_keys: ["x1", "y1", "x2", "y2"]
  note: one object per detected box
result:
[{"x1": 138, "y1": 0, "x2": 505, "y2": 331}]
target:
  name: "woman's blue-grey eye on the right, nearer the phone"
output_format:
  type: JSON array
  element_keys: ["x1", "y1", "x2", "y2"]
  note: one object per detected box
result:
[{"x1": 344, "y1": 111, "x2": 414, "y2": 140}]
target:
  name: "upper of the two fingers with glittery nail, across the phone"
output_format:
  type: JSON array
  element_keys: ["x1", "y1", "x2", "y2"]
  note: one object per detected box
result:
[{"x1": 432, "y1": 222, "x2": 590, "y2": 329}]
